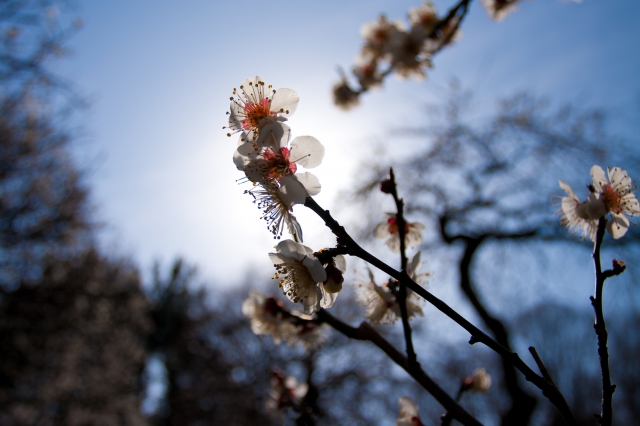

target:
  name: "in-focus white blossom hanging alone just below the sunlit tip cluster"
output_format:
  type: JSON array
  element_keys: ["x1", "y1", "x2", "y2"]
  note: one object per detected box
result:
[{"x1": 269, "y1": 240, "x2": 346, "y2": 314}]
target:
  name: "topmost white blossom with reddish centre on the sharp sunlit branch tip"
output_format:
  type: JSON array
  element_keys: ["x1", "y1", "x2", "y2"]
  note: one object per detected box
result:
[{"x1": 225, "y1": 76, "x2": 299, "y2": 140}]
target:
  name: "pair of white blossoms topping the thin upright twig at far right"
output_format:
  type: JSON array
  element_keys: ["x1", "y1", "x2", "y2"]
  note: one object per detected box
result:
[{"x1": 558, "y1": 165, "x2": 640, "y2": 242}]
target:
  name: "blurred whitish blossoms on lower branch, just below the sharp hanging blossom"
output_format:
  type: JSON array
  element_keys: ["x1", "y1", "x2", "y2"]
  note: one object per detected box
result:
[{"x1": 242, "y1": 291, "x2": 326, "y2": 350}]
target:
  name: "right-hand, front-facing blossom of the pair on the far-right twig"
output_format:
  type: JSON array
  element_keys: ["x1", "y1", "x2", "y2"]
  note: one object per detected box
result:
[{"x1": 591, "y1": 165, "x2": 640, "y2": 239}]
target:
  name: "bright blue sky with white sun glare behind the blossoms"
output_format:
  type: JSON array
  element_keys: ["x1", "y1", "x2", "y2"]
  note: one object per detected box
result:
[{"x1": 58, "y1": 0, "x2": 640, "y2": 286}]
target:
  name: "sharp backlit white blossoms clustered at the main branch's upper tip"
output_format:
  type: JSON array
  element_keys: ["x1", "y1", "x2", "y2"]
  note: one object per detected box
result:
[{"x1": 223, "y1": 76, "x2": 324, "y2": 241}]
